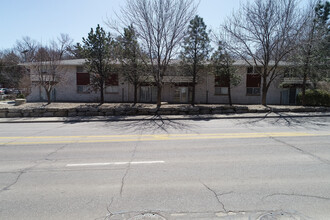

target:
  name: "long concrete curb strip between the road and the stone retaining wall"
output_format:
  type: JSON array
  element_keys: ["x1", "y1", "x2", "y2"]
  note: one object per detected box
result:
[{"x1": 0, "y1": 112, "x2": 330, "y2": 123}]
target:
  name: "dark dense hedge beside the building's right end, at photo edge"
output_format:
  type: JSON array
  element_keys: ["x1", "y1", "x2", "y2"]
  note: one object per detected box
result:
[{"x1": 297, "y1": 89, "x2": 330, "y2": 106}]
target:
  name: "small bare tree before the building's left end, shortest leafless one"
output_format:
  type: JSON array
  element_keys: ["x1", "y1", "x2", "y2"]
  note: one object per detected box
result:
[{"x1": 27, "y1": 35, "x2": 72, "y2": 104}]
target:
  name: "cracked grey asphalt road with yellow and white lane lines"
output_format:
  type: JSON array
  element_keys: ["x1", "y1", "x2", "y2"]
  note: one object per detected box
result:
[{"x1": 0, "y1": 117, "x2": 330, "y2": 220}]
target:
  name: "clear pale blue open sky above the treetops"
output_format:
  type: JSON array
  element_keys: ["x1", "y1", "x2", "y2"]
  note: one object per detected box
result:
[{"x1": 0, "y1": 0, "x2": 310, "y2": 49}]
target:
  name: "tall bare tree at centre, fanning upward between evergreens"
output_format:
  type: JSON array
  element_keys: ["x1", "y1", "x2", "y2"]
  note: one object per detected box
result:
[{"x1": 108, "y1": 0, "x2": 196, "y2": 107}]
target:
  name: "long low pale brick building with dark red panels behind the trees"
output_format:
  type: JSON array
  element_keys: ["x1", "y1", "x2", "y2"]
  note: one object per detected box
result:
[{"x1": 23, "y1": 59, "x2": 301, "y2": 104}]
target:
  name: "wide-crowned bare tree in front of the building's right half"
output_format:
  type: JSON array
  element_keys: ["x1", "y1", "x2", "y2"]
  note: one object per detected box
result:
[{"x1": 223, "y1": 0, "x2": 305, "y2": 105}]
